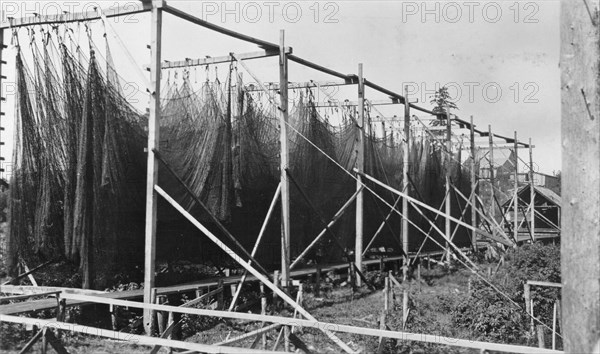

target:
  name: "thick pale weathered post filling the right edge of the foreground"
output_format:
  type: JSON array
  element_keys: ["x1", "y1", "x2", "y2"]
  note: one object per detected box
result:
[{"x1": 560, "y1": 0, "x2": 600, "y2": 353}]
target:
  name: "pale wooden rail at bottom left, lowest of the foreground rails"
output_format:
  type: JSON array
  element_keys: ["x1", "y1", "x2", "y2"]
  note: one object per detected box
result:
[{"x1": 0, "y1": 314, "x2": 283, "y2": 353}]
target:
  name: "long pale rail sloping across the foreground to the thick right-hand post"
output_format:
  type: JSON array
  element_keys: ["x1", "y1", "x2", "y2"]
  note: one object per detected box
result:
[{"x1": 44, "y1": 294, "x2": 562, "y2": 353}]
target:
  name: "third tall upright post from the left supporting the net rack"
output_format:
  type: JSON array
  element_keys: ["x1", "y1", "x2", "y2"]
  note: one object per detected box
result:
[{"x1": 354, "y1": 63, "x2": 366, "y2": 286}]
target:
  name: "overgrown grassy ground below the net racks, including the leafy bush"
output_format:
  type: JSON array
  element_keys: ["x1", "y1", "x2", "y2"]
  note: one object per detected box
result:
[{"x1": 0, "y1": 244, "x2": 562, "y2": 354}]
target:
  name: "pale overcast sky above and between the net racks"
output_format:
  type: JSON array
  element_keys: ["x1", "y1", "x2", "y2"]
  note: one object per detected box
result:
[{"x1": 1, "y1": 0, "x2": 561, "y2": 174}]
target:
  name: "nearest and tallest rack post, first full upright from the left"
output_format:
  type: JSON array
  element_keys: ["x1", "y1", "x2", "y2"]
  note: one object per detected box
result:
[{"x1": 144, "y1": 1, "x2": 163, "y2": 334}]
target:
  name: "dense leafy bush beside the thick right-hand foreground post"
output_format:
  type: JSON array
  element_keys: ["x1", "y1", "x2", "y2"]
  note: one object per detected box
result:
[{"x1": 453, "y1": 243, "x2": 560, "y2": 344}]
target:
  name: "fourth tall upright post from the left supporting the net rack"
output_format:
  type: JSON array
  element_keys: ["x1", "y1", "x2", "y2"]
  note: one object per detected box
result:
[{"x1": 401, "y1": 85, "x2": 410, "y2": 281}]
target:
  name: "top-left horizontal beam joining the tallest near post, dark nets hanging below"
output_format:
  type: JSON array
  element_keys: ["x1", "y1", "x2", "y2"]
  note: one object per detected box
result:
[{"x1": 0, "y1": 2, "x2": 150, "y2": 29}]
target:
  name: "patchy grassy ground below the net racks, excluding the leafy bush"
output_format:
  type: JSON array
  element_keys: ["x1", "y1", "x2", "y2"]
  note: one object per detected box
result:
[{"x1": 1, "y1": 269, "x2": 482, "y2": 353}]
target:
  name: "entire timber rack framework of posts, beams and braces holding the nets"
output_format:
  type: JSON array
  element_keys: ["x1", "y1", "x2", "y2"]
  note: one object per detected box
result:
[{"x1": 0, "y1": 0, "x2": 576, "y2": 353}]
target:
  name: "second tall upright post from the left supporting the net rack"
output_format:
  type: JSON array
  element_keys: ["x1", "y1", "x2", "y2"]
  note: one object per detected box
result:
[{"x1": 279, "y1": 30, "x2": 290, "y2": 288}]
